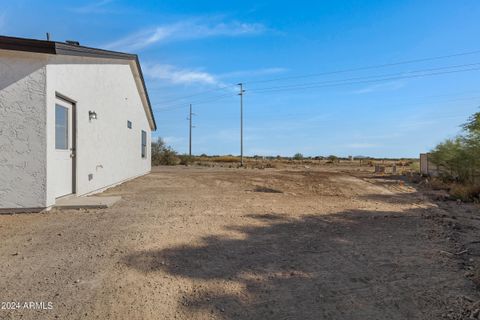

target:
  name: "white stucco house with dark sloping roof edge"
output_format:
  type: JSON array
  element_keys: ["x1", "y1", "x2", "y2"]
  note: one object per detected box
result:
[{"x1": 0, "y1": 36, "x2": 156, "y2": 212}]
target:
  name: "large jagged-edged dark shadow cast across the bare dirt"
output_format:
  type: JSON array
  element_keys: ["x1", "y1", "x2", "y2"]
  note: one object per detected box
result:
[{"x1": 124, "y1": 206, "x2": 465, "y2": 320}]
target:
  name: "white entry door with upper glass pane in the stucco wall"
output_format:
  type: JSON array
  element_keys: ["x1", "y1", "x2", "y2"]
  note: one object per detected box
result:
[{"x1": 54, "y1": 98, "x2": 75, "y2": 198}]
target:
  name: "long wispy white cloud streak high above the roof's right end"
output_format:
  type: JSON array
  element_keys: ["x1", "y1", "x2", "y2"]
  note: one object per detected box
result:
[{"x1": 103, "y1": 19, "x2": 265, "y2": 51}]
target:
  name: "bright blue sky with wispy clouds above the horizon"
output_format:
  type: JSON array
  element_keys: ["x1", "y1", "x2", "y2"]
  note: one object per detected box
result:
[{"x1": 0, "y1": 0, "x2": 480, "y2": 157}]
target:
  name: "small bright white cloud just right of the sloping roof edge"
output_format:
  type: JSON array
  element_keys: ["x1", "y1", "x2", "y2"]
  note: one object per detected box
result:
[{"x1": 144, "y1": 64, "x2": 220, "y2": 85}]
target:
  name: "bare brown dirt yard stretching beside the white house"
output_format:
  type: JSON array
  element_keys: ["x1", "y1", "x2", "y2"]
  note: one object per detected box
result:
[{"x1": 0, "y1": 167, "x2": 480, "y2": 319}]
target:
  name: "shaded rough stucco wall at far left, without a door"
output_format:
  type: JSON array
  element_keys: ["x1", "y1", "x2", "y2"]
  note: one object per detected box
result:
[{"x1": 0, "y1": 50, "x2": 47, "y2": 211}]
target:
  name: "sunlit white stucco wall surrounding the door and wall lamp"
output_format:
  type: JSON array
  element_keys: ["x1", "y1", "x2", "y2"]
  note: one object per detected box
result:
[{"x1": 46, "y1": 56, "x2": 151, "y2": 205}]
